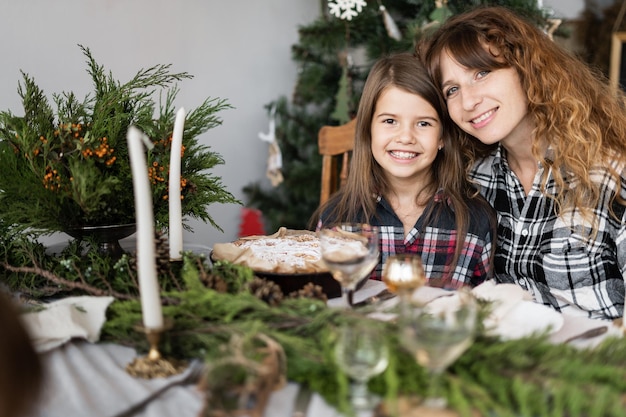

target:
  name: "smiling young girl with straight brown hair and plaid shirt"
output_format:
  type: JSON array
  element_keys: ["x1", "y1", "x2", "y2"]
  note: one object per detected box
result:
[{"x1": 313, "y1": 53, "x2": 495, "y2": 288}]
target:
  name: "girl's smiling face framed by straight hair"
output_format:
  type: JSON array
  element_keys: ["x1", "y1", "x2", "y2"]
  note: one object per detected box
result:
[{"x1": 372, "y1": 86, "x2": 442, "y2": 185}]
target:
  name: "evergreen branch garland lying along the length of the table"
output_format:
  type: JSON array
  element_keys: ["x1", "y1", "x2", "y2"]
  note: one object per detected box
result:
[{"x1": 0, "y1": 228, "x2": 626, "y2": 417}]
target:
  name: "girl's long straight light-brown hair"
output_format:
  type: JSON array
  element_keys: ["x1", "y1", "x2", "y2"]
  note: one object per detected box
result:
[{"x1": 311, "y1": 53, "x2": 495, "y2": 282}]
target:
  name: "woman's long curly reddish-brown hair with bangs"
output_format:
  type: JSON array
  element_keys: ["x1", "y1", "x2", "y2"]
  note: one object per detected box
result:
[{"x1": 416, "y1": 7, "x2": 626, "y2": 228}]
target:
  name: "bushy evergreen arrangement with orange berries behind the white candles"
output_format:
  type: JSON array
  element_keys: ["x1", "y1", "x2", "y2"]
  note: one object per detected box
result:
[{"x1": 0, "y1": 46, "x2": 239, "y2": 234}]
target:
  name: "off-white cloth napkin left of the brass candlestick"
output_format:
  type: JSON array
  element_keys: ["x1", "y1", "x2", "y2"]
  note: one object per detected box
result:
[{"x1": 21, "y1": 296, "x2": 114, "y2": 352}]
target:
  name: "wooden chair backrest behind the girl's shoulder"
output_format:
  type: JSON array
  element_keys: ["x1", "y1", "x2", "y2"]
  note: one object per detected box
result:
[{"x1": 317, "y1": 119, "x2": 356, "y2": 205}]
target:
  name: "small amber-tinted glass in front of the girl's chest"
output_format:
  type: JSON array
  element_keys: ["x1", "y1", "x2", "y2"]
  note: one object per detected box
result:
[{"x1": 382, "y1": 253, "x2": 427, "y2": 308}]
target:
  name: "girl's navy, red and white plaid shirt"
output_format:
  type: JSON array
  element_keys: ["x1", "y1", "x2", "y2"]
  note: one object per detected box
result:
[{"x1": 318, "y1": 189, "x2": 495, "y2": 289}]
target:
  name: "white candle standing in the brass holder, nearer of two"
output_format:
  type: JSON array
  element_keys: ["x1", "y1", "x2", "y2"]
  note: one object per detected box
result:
[{"x1": 126, "y1": 126, "x2": 163, "y2": 329}]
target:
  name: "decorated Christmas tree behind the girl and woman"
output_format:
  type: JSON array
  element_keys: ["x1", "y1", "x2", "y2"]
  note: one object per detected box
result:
[{"x1": 243, "y1": 0, "x2": 547, "y2": 232}]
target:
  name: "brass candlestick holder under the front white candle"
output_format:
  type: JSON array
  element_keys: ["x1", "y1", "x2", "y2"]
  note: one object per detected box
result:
[{"x1": 126, "y1": 319, "x2": 188, "y2": 379}]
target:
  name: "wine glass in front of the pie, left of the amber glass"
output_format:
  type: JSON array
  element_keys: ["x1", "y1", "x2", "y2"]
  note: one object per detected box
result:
[{"x1": 320, "y1": 223, "x2": 380, "y2": 308}]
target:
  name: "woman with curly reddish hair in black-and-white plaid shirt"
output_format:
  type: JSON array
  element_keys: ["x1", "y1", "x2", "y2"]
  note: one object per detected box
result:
[{"x1": 417, "y1": 7, "x2": 626, "y2": 319}]
